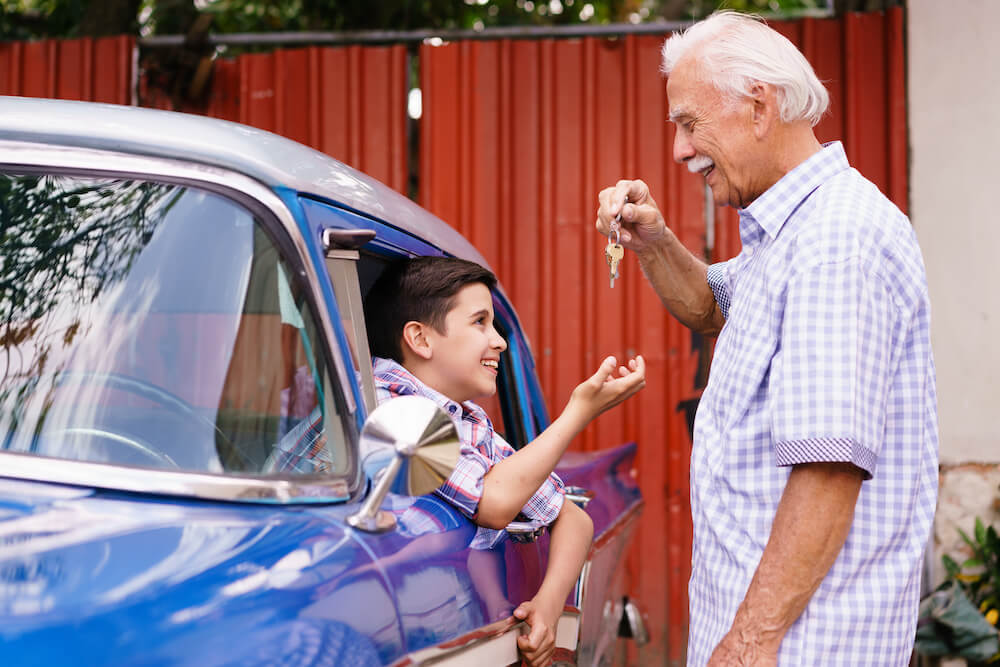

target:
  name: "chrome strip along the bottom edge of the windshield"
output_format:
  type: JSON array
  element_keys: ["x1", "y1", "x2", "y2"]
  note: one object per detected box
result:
[{"x1": 0, "y1": 452, "x2": 349, "y2": 503}]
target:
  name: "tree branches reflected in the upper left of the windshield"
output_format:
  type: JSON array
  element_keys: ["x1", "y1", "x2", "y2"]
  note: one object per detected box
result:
[{"x1": 0, "y1": 175, "x2": 173, "y2": 384}]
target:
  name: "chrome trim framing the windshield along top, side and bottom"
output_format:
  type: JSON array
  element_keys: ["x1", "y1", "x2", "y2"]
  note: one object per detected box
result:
[{"x1": 0, "y1": 139, "x2": 359, "y2": 503}]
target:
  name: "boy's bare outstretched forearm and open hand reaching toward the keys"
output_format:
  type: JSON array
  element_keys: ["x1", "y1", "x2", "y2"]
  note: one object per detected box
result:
[{"x1": 476, "y1": 356, "x2": 646, "y2": 530}]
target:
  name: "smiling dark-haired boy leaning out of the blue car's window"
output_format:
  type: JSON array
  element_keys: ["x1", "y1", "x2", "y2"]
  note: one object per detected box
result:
[{"x1": 365, "y1": 257, "x2": 645, "y2": 666}]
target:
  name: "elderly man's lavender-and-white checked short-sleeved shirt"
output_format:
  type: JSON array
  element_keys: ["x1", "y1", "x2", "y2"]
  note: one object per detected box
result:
[{"x1": 688, "y1": 143, "x2": 938, "y2": 667}]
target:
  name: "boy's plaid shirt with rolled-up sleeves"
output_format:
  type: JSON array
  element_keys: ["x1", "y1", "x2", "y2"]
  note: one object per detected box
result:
[{"x1": 373, "y1": 357, "x2": 565, "y2": 549}]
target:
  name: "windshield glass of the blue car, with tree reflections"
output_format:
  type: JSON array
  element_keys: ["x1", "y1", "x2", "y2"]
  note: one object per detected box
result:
[{"x1": 0, "y1": 173, "x2": 351, "y2": 475}]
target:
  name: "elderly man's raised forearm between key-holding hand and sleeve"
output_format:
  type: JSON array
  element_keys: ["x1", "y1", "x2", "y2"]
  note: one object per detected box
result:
[{"x1": 638, "y1": 232, "x2": 725, "y2": 336}]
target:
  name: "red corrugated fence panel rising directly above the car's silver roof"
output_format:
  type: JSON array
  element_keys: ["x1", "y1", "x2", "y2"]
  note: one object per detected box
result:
[{"x1": 141, "y1": 45, "x2": 409, "y2": 194}]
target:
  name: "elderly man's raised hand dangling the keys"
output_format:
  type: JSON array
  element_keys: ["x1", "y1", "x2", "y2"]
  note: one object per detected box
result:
[{"x1": 597, "y1": 180, "x2": 669, "y2": 252}]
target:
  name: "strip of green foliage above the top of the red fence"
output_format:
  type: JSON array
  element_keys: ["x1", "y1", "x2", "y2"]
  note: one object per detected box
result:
[{"x1": 0, "y1": 0, "x2": 826, "y2": 39}]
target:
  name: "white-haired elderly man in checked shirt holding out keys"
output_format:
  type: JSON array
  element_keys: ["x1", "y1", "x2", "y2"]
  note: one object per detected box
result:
[{"x1": 597, "y1": 13, "x2": 937, "y2": 667}]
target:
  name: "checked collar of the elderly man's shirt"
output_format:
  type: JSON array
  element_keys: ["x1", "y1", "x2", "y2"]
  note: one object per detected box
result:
[{"x1": 739, "y1": 141, "x2": 851, "y2": 242}]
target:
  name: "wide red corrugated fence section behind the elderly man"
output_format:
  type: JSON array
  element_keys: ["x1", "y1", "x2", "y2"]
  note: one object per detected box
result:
[{"x1": 419, "y1": 9, "x2": 906, "y2": 664}]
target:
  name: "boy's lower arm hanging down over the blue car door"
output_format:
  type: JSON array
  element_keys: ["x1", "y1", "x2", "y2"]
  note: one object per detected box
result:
[{"x1": 514, "y1": 501, "x2": 594, "y2": 667}]
